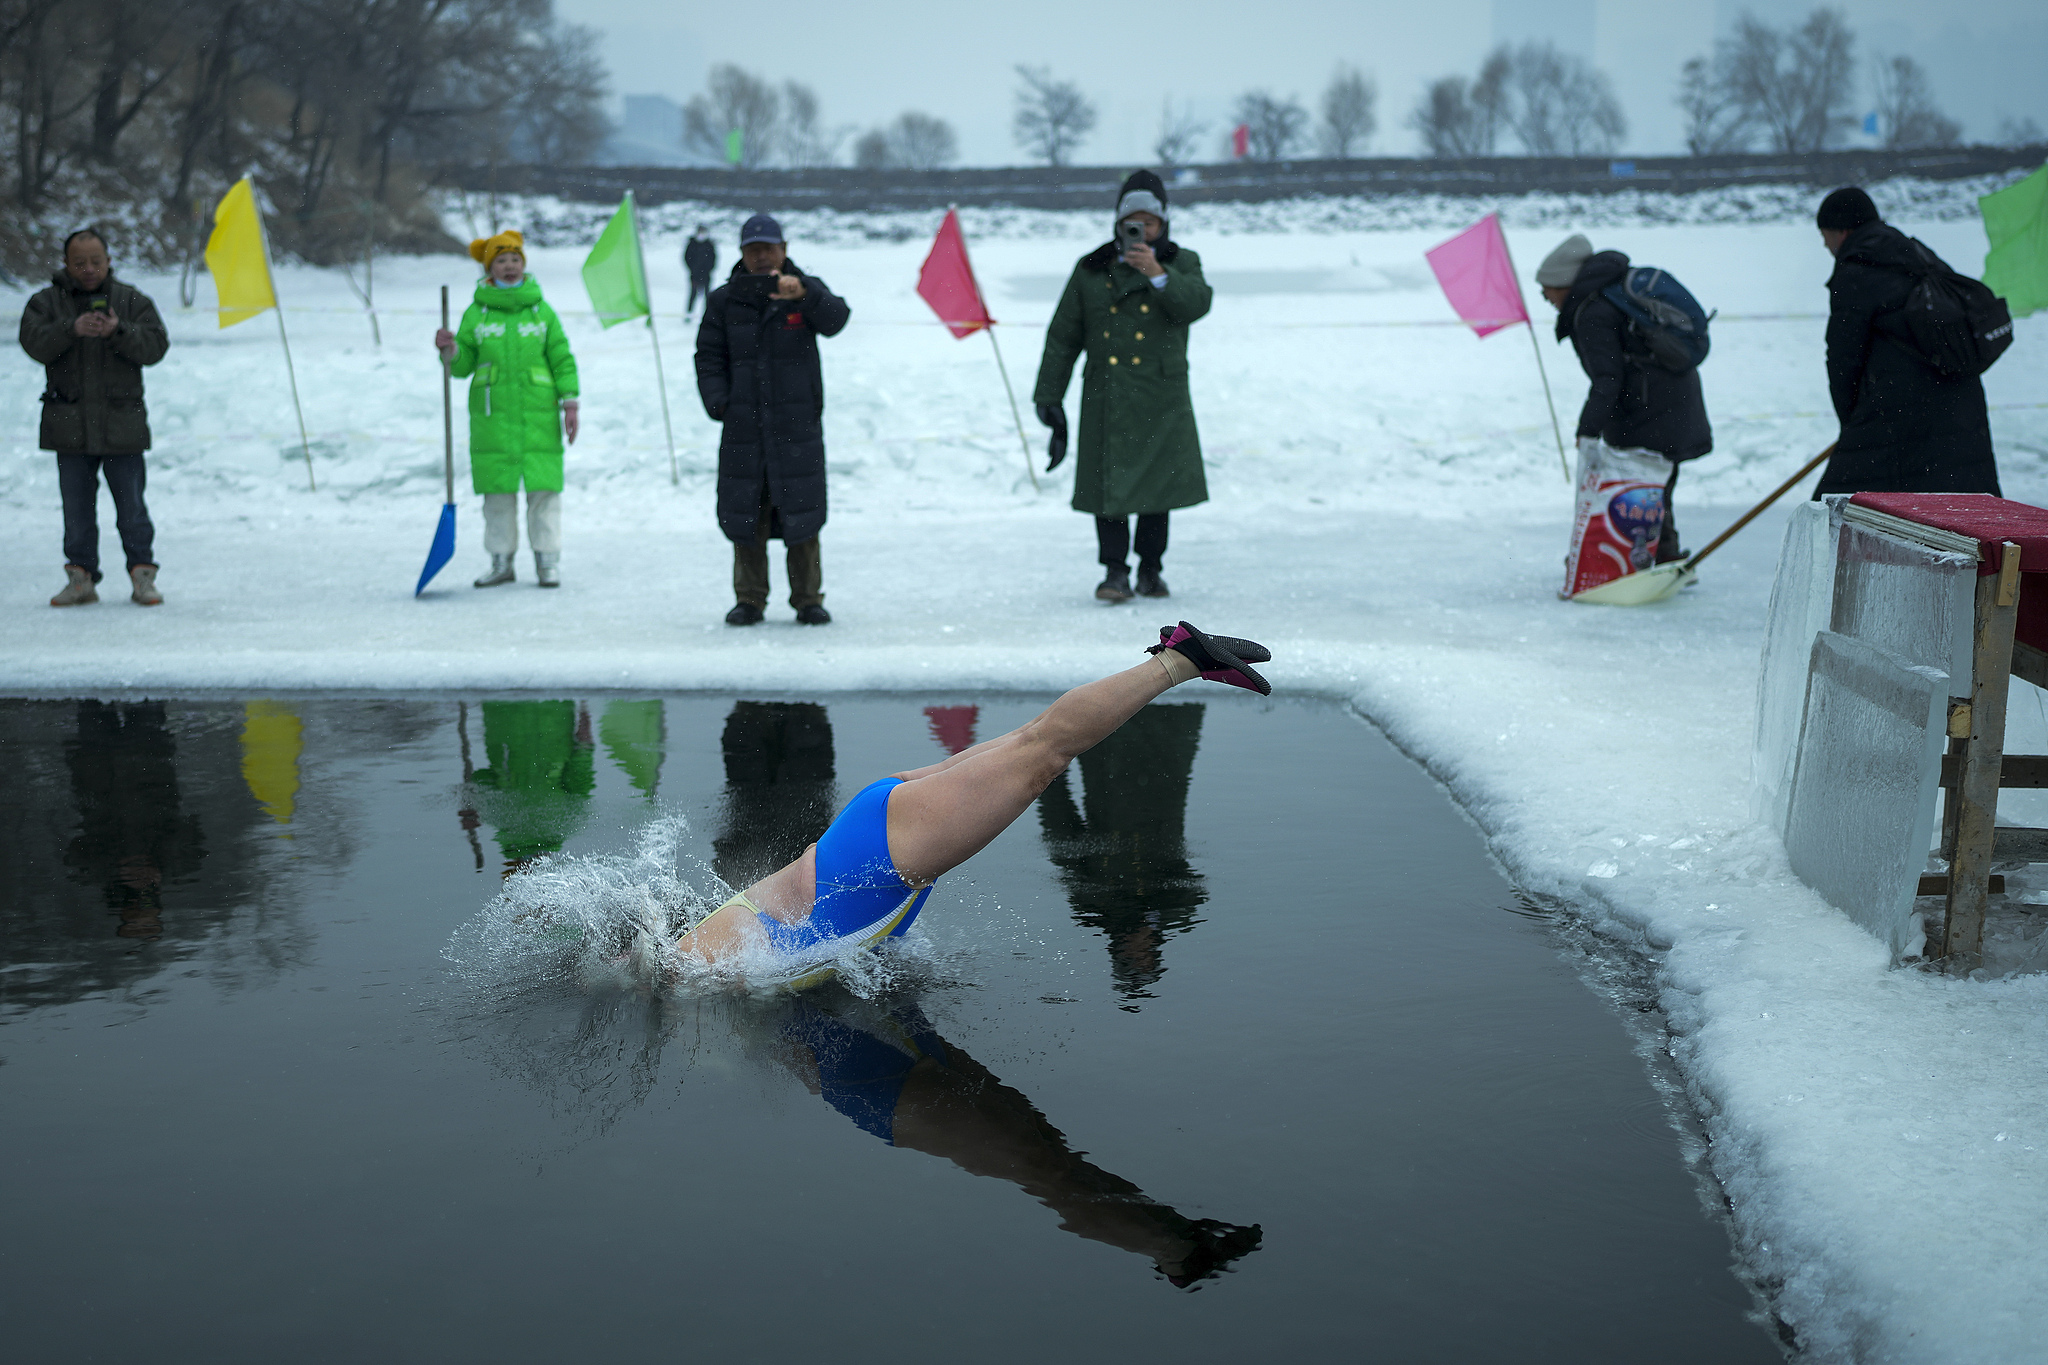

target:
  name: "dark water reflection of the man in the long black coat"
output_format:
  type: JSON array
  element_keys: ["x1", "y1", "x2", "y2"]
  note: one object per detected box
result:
[{"x1": 711, "y1": 702, "x2": 834, "y2": 886}]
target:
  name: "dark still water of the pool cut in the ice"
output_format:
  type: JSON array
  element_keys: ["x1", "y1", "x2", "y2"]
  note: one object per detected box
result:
[{"x1": 0, "y1": 696, "x2": 1778, "y2": 1365}]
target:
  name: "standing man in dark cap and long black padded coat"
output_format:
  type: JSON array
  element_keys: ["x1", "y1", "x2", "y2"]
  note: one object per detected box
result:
[{"x1": 696, "y1": 213, "x2": 850, "y2": 626}]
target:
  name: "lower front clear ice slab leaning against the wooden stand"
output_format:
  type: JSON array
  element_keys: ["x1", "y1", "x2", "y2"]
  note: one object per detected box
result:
[{"x1": 1784, "y1": 630, "x2": 1950, "y2": 958}]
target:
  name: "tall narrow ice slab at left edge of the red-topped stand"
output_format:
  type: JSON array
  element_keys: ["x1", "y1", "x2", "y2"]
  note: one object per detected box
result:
[{"x1": 1749, "y1": 499, "x2": 1841, "y2": 835}]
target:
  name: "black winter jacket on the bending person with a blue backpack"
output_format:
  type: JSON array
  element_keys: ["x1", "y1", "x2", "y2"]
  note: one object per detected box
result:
[{"x1": 1556, "y1": 252, "x2": 1714, "y2": 460}]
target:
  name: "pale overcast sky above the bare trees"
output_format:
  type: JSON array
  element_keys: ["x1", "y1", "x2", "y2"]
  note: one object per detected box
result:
[{"x1": 555, "y1": 0, "x2": 2048, "y2": 166}]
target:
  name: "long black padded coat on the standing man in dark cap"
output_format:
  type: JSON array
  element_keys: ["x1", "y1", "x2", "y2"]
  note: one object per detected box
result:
[{"x1": 696, "y1": 262, "x2": 850, "y2": 544}]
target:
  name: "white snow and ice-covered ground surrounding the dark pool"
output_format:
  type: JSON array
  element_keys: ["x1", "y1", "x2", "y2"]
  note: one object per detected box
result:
[{"x1": 0, "y1": 194, "x2": 2048, "y2": 1361}]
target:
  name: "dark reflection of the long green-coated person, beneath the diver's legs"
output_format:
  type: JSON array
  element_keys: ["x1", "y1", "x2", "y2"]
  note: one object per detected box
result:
[{"x1": 1038, "y1": 702, "x2": 1208, "y2": 1009}]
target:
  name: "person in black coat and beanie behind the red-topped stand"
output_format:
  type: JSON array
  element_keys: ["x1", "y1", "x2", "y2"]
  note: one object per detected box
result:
[{"x1": 1815, "y1": 186, "x2": 1999, "y2": 497}]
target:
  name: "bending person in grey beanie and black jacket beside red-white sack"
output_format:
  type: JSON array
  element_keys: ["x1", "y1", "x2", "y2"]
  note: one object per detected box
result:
[{"x1": 1536, "y1": 233, "x2": 1714, "y2": 565}]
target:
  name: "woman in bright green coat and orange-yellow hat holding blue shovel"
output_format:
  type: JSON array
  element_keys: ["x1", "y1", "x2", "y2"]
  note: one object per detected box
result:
[{"x1": 434, "y1": 231, "x2": 580, "y2": 587}]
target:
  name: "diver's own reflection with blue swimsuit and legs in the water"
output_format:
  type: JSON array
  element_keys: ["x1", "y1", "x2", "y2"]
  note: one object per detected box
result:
[{"x1": 782, "y1": 997, "x2": 1260, "y2": 1287}]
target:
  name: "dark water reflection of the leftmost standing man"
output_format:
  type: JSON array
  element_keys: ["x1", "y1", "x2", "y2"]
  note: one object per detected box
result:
[{"x1": 63, "y1": 702, "x2": 207, "y2": 939}]
